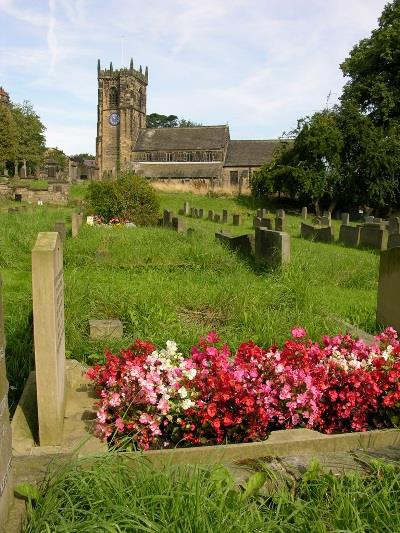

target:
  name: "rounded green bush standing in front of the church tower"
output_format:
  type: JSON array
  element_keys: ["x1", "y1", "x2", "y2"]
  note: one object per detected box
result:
[{"x1": 86, "y1": 173, "x2": 160, "y2": 226}]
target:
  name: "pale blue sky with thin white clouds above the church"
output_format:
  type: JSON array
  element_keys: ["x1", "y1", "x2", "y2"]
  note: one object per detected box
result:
[{"x1": 0, "y1": 0, "x2": 387, "y2": 155}]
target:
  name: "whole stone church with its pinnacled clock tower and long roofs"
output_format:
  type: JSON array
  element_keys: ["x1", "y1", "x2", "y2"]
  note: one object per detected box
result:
[{"x1": 96, "y1": 60, "x2": 279, "y2": 187}]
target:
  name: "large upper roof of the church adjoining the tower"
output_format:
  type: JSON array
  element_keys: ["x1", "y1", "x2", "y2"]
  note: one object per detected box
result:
[{"x1": 134, "y1": 126, "x2": 229, "y2": 152}]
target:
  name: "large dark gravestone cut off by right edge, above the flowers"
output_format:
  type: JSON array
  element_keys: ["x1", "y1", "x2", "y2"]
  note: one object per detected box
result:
[{"x1": 376, "y1": 247, "x2": 400, "y2": 331}]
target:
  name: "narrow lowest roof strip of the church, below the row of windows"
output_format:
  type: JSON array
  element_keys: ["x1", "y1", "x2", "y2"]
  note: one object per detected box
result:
[{"x1": 134, "y1": 163, "x2": 222, "y2": 179}]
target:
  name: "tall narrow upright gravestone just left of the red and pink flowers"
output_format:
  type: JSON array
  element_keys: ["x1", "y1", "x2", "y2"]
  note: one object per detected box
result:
[{"x1": 32, "y1": 233, "x2": 65, "y2": 446}]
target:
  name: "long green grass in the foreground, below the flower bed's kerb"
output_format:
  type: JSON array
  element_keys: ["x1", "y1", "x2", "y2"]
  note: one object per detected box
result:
[{"x1": 23, "y1": 453, "x2": 400, "y2": 533}]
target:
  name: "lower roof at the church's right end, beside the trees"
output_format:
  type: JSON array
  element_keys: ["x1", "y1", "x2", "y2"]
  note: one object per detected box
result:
[{"x1": 225, "y1": 140, "x2": 280, "y2": 167}]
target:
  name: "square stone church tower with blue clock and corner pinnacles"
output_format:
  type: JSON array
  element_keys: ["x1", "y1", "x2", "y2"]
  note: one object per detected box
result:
[{"x1": 96, "y1": 59, "x2": 148, "y2": 179}]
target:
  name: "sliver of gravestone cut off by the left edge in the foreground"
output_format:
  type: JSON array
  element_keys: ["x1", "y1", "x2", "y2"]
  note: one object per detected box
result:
[{"x1": 0, "y1": 276, "x2": 13, "y2": 531}]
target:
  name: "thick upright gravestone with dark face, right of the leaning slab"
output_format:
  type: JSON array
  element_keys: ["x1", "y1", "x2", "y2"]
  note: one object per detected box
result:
[{"x1": 255, "y1": 228, "x2": 290, "y2": 268}]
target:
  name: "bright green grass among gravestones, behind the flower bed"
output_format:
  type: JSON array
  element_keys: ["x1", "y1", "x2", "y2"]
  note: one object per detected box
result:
[{"x1": 0, "y1": 187, "x2": 379, "y2": 405}]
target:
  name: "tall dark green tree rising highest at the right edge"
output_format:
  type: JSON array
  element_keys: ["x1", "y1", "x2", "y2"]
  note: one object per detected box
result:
[{"x1": 340, "y1": 0, "x2": 400, "y2": 127}]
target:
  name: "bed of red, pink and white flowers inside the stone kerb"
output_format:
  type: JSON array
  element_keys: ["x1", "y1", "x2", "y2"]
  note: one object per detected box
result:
[{"x1": 88, "y1": 328, "x2": 400, "y2": 449}]
